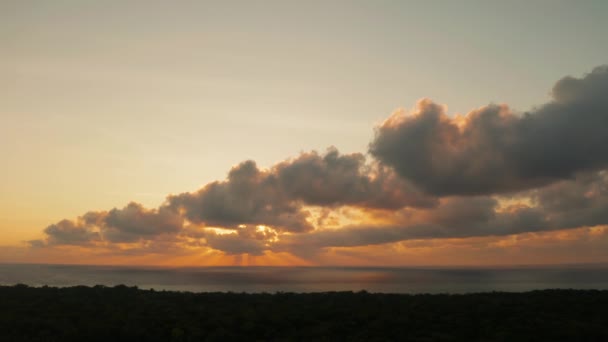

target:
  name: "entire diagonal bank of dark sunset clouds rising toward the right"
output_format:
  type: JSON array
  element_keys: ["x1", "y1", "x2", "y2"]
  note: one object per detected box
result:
[{"x1": 30, "y1": 67, "x2": 608, "y2": 257}]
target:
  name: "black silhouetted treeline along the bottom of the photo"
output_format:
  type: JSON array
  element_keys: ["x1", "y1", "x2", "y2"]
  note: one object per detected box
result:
[{"x1": 0, "y1": 285, "x2": 608, "y2": 342}]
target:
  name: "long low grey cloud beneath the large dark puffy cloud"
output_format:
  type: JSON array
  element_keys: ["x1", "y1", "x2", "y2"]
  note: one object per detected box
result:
[{"x1": 274, "y1": 170, "x2": 608, "y2": 253}]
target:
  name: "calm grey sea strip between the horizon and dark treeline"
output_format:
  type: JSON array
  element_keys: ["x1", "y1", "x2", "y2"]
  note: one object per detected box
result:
[{"x1": 0, "y1": 264, "x2": 608, "y2": 293}]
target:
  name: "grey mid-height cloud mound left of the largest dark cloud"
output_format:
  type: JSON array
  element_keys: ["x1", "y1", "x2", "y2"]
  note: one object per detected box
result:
[{"x1": 168, "y1": 148, "x2": 436, "y2": 232}]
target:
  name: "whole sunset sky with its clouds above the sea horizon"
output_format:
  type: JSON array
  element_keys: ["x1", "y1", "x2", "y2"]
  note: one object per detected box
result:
[{"x1": 0, "y1": 0, "x2": 608, "y2": 266}]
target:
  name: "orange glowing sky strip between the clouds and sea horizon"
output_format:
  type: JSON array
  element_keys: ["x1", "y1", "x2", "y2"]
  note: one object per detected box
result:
[{"x1": 0, "y1": 226, "x2": 608, "y2": 267}]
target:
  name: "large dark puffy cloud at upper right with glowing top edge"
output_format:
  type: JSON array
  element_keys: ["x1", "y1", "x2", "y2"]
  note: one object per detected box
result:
[{"x1": 370, "y1": 66, "x2": 608, "y2": 196}]
